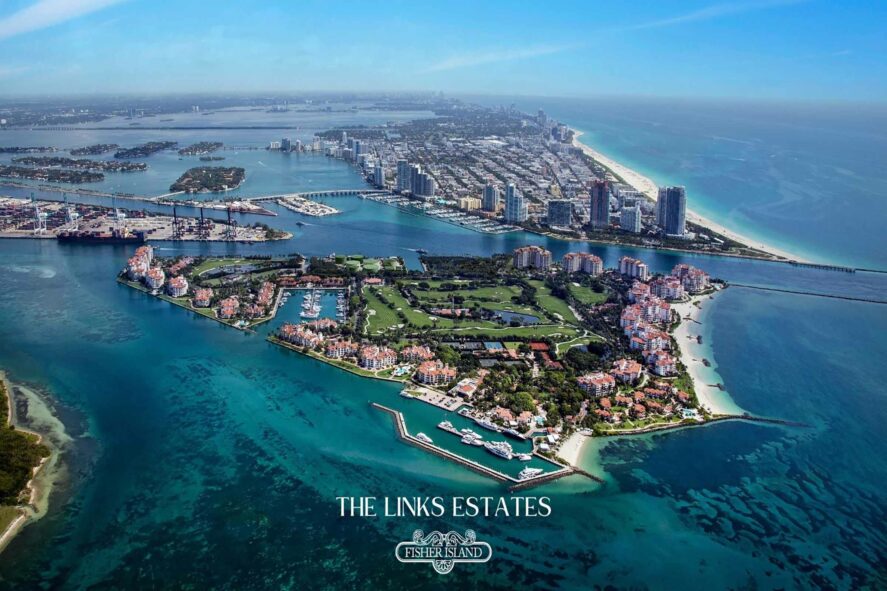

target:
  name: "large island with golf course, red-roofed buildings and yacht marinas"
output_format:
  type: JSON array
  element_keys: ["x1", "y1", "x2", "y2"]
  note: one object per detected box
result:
[{"x1": 118, "y1": 246, "x2": 744, "y2": 484}]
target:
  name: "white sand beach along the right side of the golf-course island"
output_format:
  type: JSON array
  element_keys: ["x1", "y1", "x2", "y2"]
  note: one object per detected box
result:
[{"x1": 671, "y1": 294, "x2": 744, "y2": 414}]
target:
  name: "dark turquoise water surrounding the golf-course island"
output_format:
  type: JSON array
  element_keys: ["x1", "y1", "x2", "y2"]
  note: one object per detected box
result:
[{"x1": 0, "y1": 105, "x2": 887, "y2": 589}]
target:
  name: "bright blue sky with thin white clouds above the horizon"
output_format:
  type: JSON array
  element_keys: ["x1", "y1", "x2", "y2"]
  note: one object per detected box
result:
[{"x1": 0, "y1": 0, "x2": 887, "y2": 103}]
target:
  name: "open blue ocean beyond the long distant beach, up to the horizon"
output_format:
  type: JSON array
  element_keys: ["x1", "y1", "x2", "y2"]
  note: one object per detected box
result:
[{"x1": 472, "y1": 97, "x2": 887, "y2": 269}]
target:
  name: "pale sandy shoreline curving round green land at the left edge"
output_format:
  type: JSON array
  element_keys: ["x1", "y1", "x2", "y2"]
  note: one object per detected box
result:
[{"x1": 0, "y1": 370, "x2": 71, "y2": 553}]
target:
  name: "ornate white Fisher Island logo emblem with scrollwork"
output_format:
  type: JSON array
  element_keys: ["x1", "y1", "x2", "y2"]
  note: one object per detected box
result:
[{"x1": 394, "y1": 529, "x2": 493, "y2": 575}]
